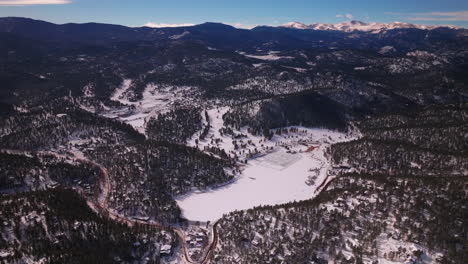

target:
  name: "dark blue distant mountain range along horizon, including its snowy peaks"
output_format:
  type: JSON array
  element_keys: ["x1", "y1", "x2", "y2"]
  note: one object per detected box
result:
[{"x1": 0, "y1": 17, "x2": 468, "y2": 50}]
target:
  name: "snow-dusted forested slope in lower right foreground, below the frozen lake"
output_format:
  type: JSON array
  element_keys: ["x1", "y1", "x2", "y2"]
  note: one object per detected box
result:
[{"x1": 214, "y1": 176, "x2": 468, "y2": 264}]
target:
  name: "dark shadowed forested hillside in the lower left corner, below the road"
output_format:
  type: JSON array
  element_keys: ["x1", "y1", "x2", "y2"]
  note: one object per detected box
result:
[{"x1": 0, "y1": 188, "x2": 177, "y2": 264}]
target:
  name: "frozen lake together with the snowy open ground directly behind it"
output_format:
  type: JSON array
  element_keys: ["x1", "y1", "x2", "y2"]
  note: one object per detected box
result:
[{"x1": 176, "y1": 107, "x2": 354, "y2": 221}]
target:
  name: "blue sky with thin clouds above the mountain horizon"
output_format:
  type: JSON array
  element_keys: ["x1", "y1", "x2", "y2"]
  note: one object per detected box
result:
[{"x1": 0, "y1": 0, "x2": 468, "y2": 28}]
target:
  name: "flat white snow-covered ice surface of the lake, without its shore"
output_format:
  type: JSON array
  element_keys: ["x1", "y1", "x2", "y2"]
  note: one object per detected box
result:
[{"x1": 176, "y1": 151, "x2": 314, "y2": 221}]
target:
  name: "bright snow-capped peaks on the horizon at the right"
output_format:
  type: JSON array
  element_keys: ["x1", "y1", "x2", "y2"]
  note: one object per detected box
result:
[{"x1": 280, "y1": 20, "x2": 457, "y2": 33}]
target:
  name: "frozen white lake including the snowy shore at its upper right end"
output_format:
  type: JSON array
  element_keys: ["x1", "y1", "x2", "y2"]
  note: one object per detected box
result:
[{"x1": 176, "y1": 125, "x2": 349, "y2": 221}]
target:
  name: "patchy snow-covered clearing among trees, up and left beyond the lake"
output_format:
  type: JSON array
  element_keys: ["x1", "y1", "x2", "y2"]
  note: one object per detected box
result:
[{"x1": 103, "y1": 79, "x2": 196, "y2": 134}]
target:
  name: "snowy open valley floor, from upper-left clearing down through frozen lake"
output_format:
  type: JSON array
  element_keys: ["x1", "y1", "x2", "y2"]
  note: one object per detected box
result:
[{"x1": 104, "y1": 87, "x2": 359, "y2": 223}]
